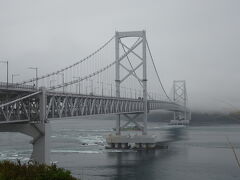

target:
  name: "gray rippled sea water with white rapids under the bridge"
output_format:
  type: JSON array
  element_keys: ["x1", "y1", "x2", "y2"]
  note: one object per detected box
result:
[{"x1": 0, "y1": 119, "x2": 240, "y2": 180}]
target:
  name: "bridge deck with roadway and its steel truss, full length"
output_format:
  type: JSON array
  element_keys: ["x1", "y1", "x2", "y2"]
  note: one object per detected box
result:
[{"x1": 0, "y1": 84, "x2": 185, "y2": 123}]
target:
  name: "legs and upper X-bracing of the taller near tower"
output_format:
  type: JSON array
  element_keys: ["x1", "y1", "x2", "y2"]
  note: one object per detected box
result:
[{"x1": 115, "y1": 31, "x2": 148, "y2": 135}]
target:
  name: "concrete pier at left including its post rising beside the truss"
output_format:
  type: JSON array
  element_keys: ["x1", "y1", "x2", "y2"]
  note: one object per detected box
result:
[{"x1": 0, "y1": 88, "x2": 50, "y2": 164}]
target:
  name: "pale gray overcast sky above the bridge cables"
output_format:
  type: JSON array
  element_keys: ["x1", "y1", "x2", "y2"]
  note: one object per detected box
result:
[{"x1": 0, "y1": 0, "x2": 240, "y2": 111}]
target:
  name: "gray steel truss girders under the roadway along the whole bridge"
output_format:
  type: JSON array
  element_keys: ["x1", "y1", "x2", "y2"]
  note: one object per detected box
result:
[{"x1": 0, "y1": 92, "x2": 184, "y2": 123}]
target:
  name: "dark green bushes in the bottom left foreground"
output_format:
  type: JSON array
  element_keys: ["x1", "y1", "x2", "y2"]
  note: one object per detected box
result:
[{"x1": 0, "y1": 161, "x2": 77, "y2": 180}]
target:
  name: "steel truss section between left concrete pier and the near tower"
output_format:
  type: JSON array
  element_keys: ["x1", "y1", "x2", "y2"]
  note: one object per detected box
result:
[{"x1": 46, "y1": 94, "x2": 143, "y2": 118}]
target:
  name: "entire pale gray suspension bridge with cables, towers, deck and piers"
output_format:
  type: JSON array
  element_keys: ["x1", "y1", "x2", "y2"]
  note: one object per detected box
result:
[{"x1": 0, "y1": 31, "x2": 191, "y2": 163}]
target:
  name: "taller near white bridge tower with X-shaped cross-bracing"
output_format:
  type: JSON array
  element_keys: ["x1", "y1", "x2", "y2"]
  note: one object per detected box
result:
[{"x1": 115, "y1": 31, "x2": 148, "y2": 135}]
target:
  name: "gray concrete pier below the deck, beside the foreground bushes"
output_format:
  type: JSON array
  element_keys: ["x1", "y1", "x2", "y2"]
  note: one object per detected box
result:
[{"x1": 0, "y1": 123, "x2": 51, "y2": 164}]
